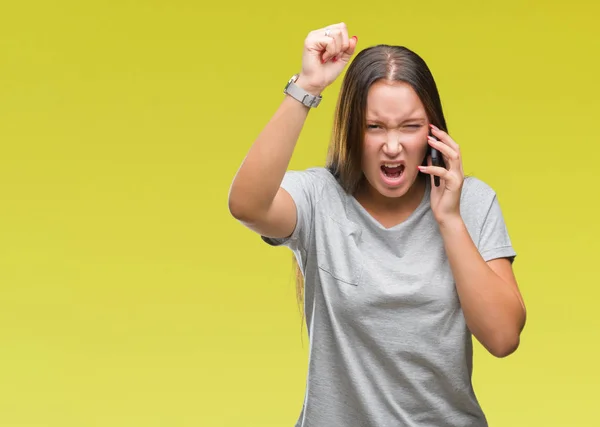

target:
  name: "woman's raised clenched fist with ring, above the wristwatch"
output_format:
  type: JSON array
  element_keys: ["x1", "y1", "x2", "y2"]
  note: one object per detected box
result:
[{"x1": 296, "y1": 22, "x2": 358, "y2": 95}]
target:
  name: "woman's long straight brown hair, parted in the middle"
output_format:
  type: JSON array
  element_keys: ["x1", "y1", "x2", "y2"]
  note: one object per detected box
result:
[{"x1": 293, "y1": 44, "x2": 448, "y2": 326}]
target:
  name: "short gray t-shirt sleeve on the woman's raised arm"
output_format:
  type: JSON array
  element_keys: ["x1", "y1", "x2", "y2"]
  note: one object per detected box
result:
[{"x1": 261, "y1": 168, "x2": 322, "y2": 251}]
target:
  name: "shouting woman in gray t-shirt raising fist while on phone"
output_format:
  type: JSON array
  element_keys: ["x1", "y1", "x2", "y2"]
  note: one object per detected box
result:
[{"x1": 229, "y1": 23, "x2": 526, "y2": 427}]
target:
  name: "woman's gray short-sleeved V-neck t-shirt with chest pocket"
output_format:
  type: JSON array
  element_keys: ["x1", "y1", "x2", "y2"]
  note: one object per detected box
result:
[{"x1": 262, "y1": 168, "x2": 516, "y2": 427}]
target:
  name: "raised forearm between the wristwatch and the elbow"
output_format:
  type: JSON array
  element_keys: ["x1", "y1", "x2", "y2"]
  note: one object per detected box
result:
[{"x1": 229, "y1": 84, "x2": 316, "y2": 216}]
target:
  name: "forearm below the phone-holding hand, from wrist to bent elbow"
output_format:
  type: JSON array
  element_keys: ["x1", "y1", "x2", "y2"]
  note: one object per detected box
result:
[{"x1": 440, "y1": 218, "x2": 525, "y2": 356}]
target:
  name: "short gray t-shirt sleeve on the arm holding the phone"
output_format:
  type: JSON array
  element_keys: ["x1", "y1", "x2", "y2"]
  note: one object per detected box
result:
[{"x1": 479, "y1": 194, "x2": 517, "y2": 263}]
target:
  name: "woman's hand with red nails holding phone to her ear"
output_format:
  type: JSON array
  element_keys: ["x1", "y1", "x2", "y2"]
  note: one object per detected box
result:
[{"x1": 419, "y1": 125, "x2": 464, "y2": 224}]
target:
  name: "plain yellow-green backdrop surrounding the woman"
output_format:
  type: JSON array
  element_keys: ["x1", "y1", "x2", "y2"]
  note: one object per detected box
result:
[{"x1": 0, "y1": 0, "x2": 600, "y2": 427}]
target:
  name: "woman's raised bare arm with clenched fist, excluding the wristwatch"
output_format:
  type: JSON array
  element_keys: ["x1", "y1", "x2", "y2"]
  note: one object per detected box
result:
[{"x1": 229, "y1": 23, "x2": 356, "y2": 238}]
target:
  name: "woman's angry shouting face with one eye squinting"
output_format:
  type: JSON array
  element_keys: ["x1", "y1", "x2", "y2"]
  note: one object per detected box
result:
[{"x1": 361, "y1": 81, "x2": 429, "y2": 204}]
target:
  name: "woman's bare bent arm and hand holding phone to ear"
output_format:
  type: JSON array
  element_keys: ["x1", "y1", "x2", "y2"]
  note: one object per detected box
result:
[{"x1": 419, "y1": 125, "x2": 526, "y2": 357}]
